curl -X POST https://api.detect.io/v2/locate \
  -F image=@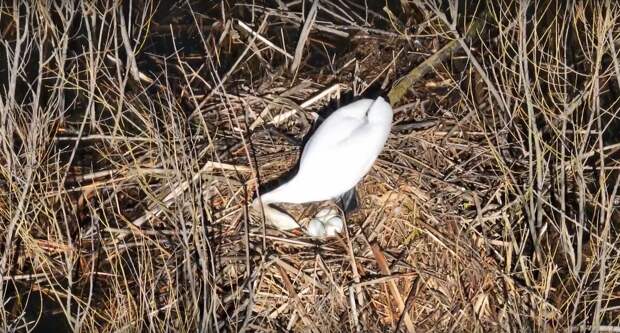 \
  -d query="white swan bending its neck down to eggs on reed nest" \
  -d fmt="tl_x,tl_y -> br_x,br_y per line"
252,97 -> 393,230
